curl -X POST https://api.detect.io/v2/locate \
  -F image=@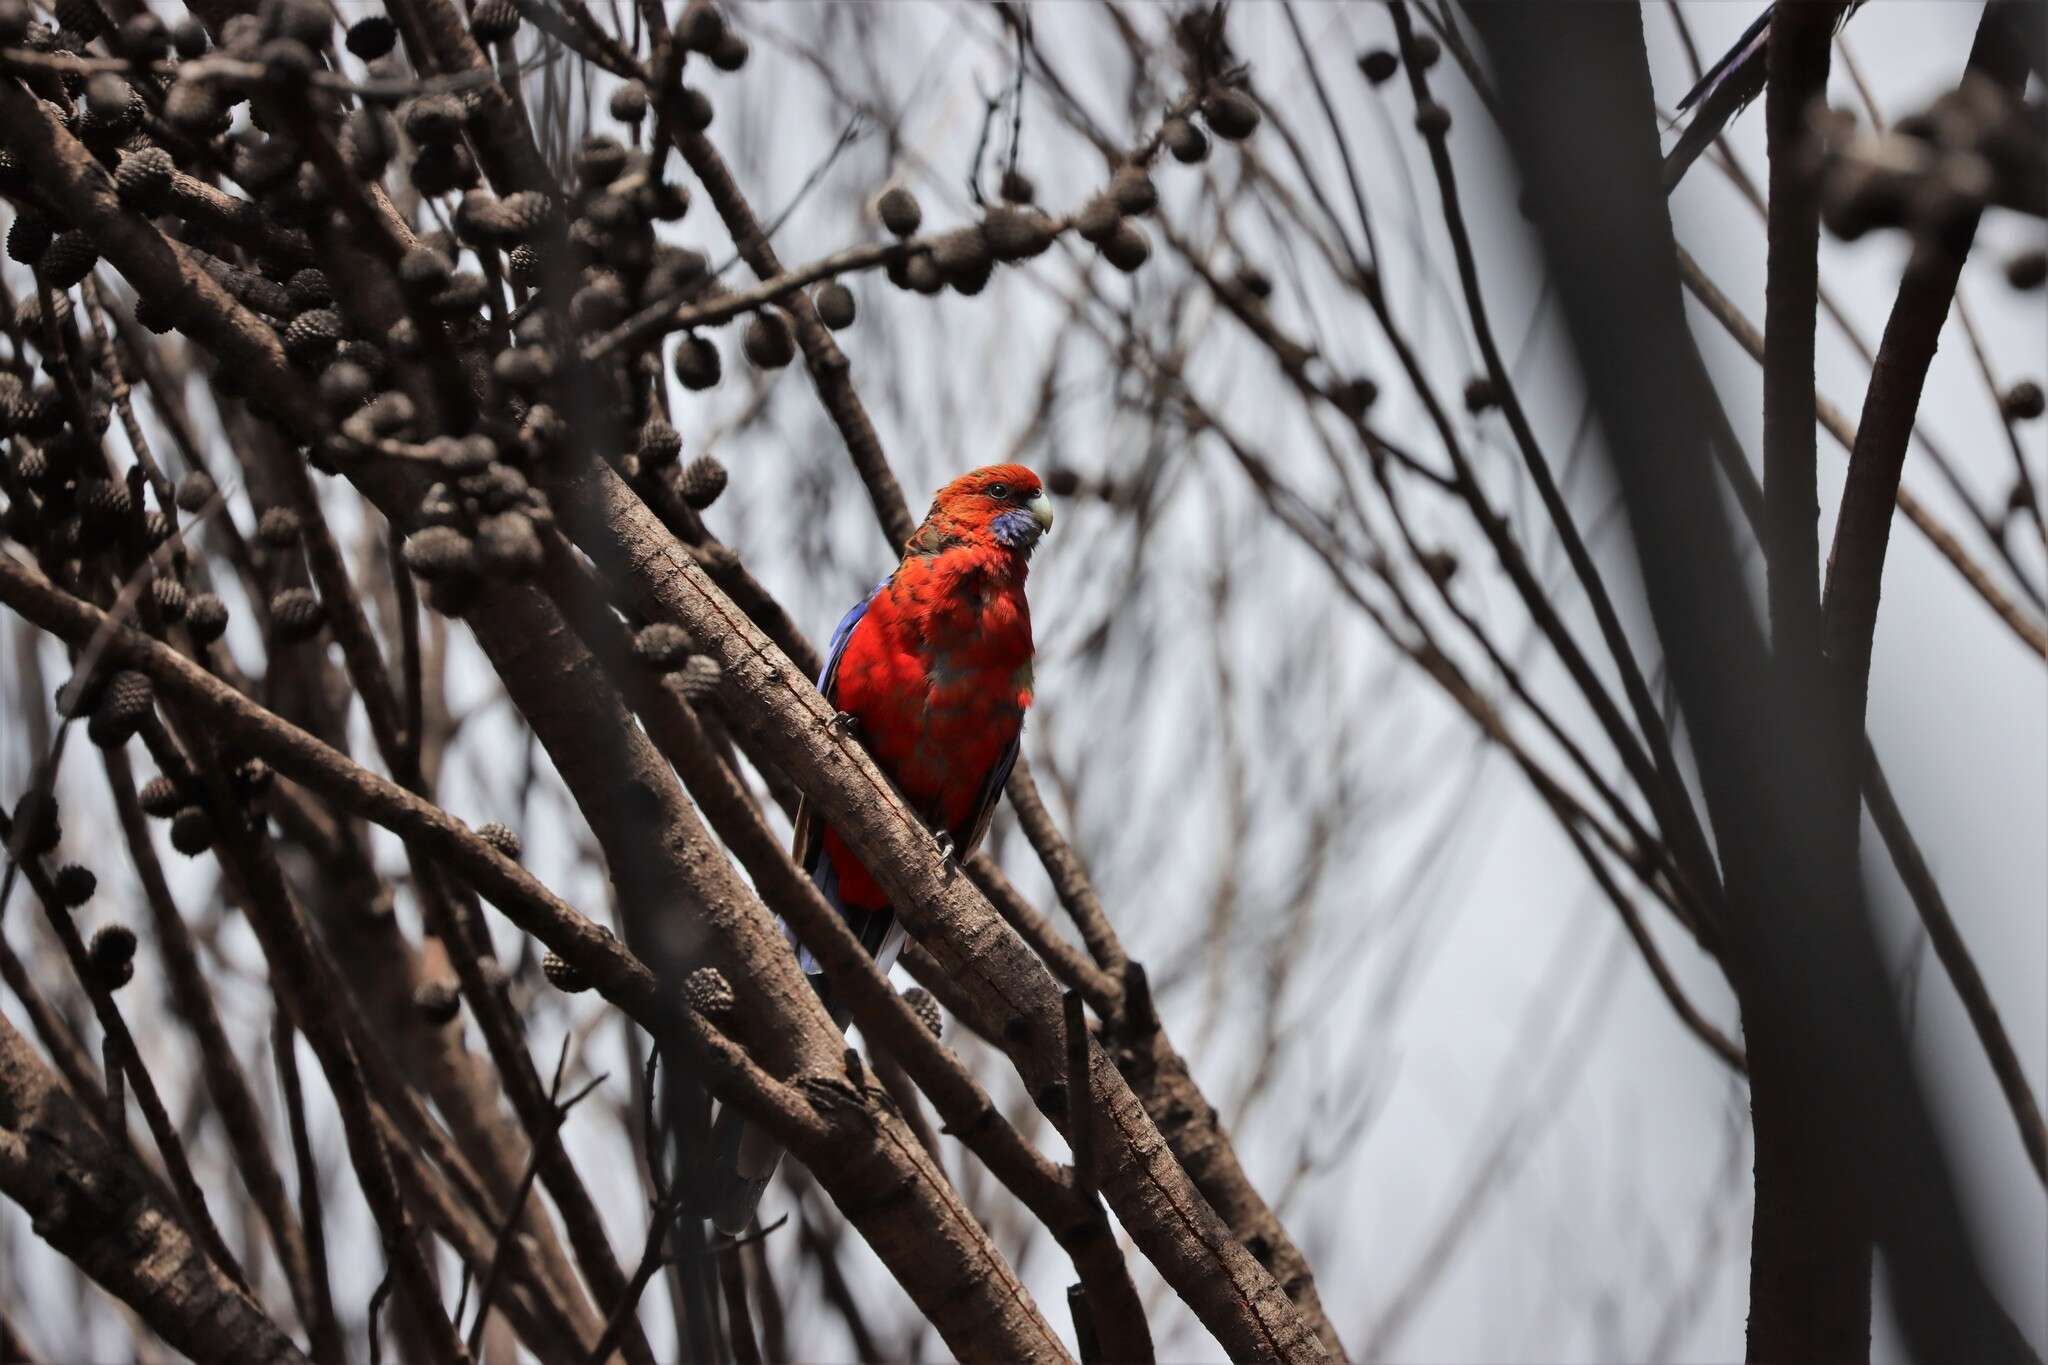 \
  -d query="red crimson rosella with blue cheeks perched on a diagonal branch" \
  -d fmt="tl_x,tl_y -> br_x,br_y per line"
713,465 -> 1053,1234
